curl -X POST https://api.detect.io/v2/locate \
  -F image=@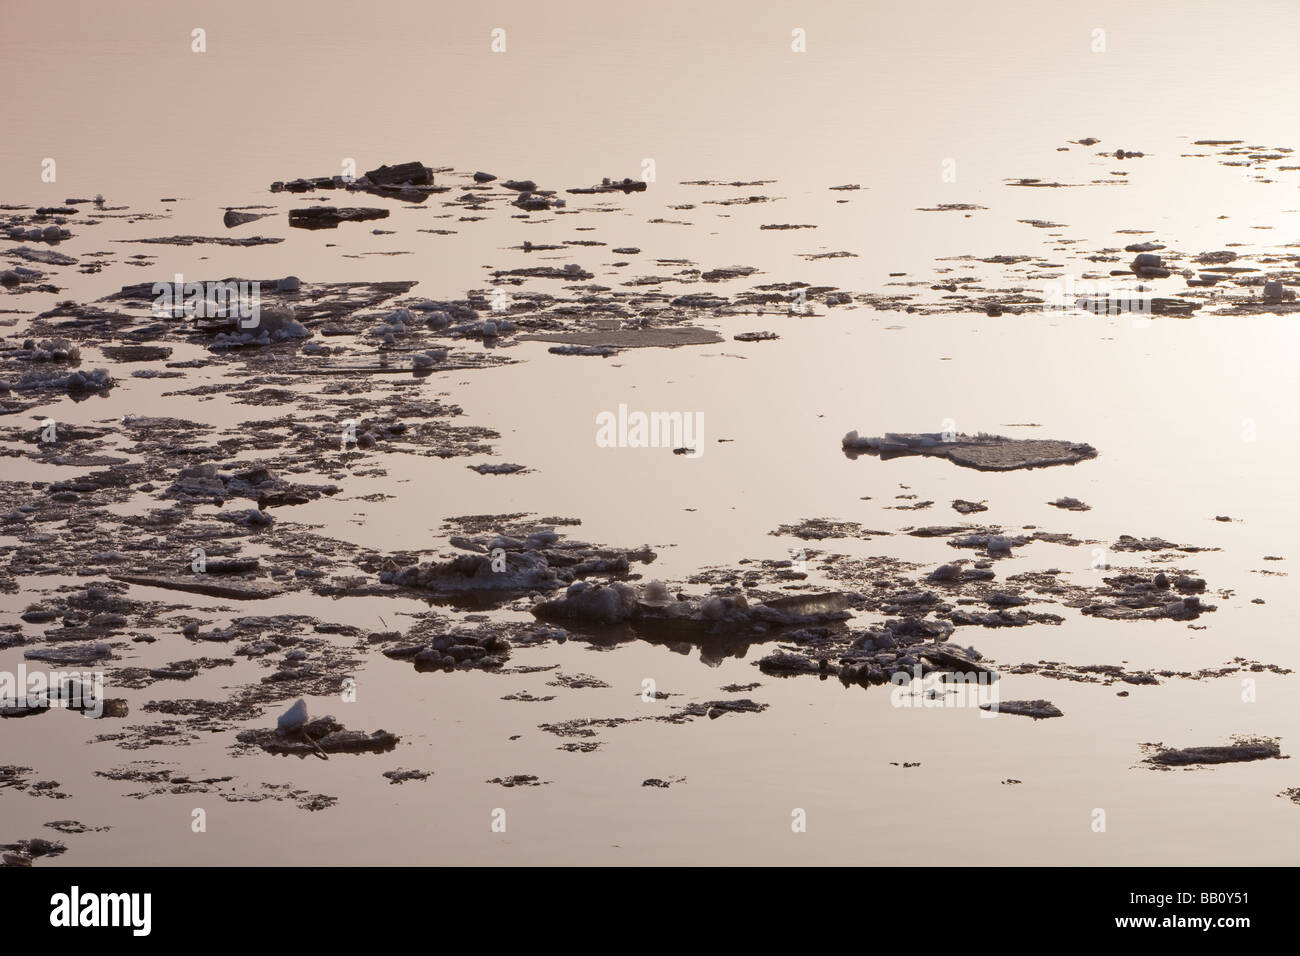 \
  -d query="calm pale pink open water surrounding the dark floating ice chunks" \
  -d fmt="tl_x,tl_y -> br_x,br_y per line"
0,0 -> 1300,865
